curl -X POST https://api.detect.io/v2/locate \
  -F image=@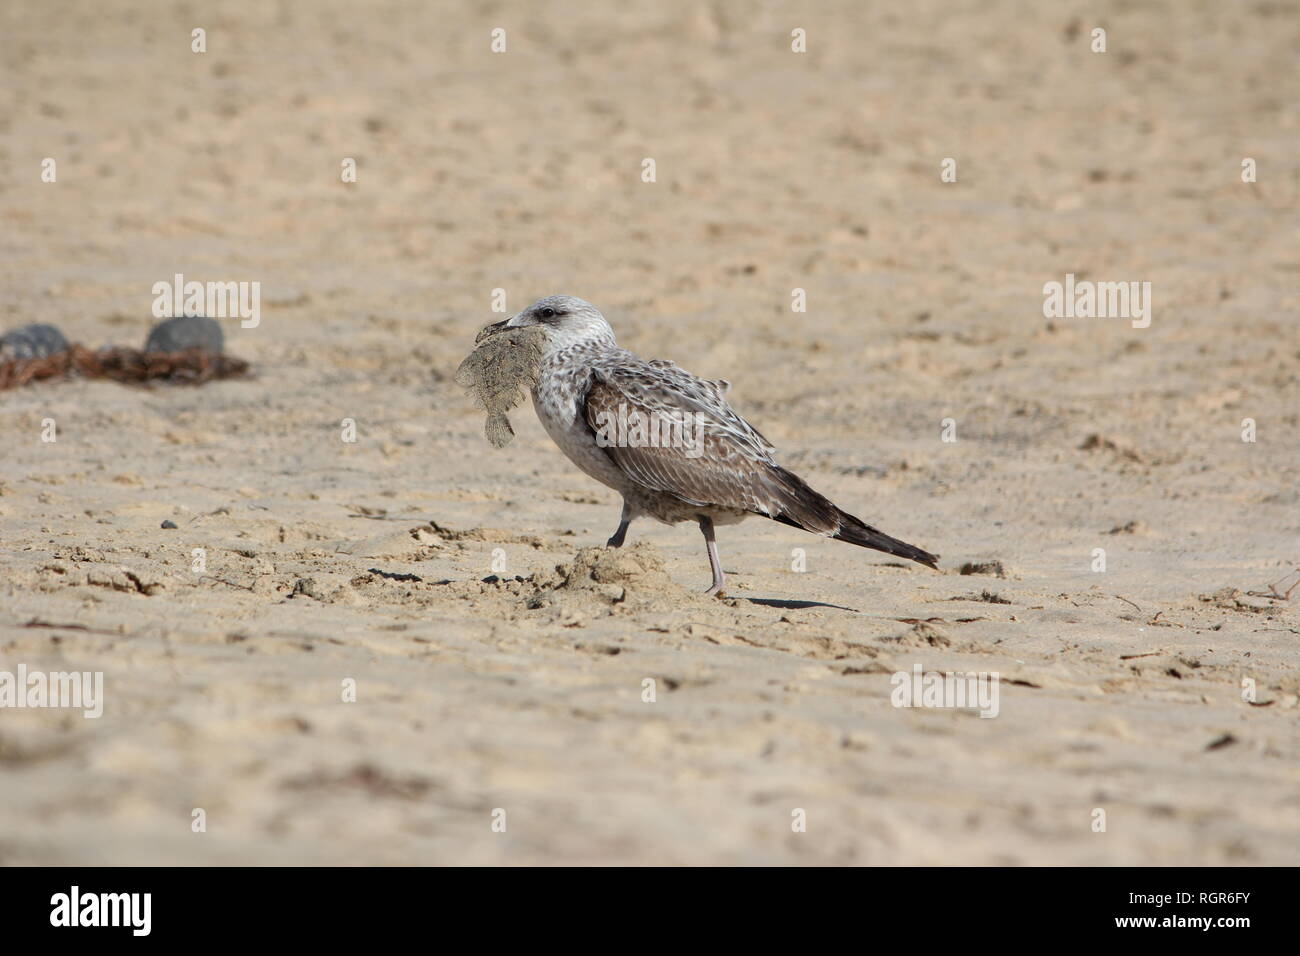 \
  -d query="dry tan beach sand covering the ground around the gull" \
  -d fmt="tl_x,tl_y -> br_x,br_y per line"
0,0 -> 1300,865
